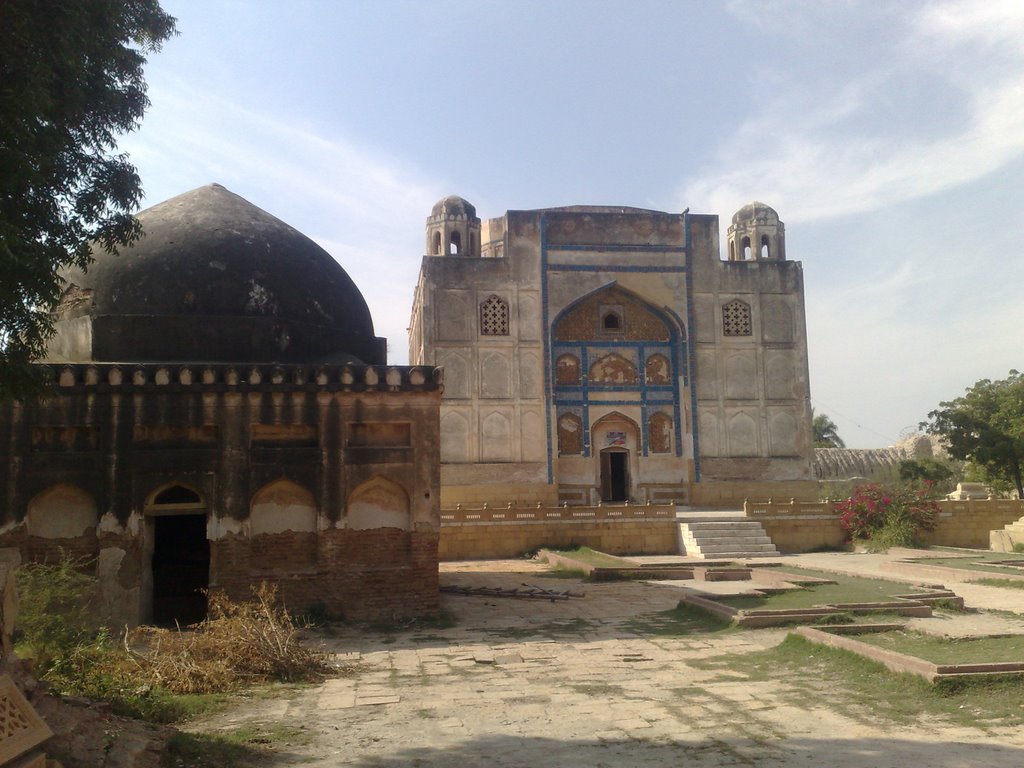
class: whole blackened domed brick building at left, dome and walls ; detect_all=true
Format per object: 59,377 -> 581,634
0,184 -> 441,624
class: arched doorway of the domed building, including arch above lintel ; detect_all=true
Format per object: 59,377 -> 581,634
142,484 -> 210,627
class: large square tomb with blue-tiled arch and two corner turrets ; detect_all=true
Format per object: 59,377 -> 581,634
410,197 -> 816,508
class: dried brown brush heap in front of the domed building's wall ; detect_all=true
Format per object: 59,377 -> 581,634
124,584 -> 333,693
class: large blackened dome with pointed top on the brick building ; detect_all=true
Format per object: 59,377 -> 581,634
47,184 -> 386,365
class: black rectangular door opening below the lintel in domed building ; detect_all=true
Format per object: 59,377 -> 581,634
153,513 -> 210,627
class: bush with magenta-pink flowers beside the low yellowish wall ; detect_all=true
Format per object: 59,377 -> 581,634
836,484 -> 939,549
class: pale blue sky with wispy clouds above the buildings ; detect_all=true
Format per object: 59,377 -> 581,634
120,0 -> 1024,447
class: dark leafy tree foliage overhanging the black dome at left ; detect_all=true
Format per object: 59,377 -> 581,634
0,0 -> 175,400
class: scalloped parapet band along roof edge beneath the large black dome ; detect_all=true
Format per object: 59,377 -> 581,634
42,362 -> 444,392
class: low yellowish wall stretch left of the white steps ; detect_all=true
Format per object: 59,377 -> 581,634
437,504 -> 679,560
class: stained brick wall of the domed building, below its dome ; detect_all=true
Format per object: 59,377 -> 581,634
0,364 -> 441,625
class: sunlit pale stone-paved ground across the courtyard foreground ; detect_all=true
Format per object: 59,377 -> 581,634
191,560 -> 1024,768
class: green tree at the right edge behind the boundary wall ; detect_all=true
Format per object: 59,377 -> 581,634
921,371 -> 1024,498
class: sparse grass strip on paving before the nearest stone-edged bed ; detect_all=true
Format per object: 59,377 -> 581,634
689,635 -> 1024,728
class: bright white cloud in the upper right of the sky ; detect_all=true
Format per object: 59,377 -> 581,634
680,2 -> 1024,221
